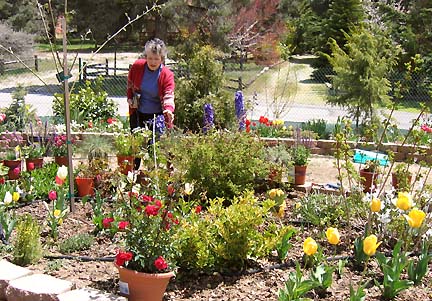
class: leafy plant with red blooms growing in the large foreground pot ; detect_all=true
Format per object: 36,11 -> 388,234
113,173 -> 179,273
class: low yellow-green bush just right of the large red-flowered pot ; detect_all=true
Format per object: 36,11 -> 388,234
176,191 -> 289,272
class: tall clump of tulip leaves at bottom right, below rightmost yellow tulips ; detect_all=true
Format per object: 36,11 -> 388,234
375,241 -> 413,300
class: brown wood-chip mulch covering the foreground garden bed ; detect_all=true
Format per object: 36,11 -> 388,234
1,192 -> 432,301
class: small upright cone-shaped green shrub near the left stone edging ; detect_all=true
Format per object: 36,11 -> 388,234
13,214 -> 42,266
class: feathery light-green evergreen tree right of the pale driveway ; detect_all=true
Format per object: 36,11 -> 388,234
327,27 -> 399,127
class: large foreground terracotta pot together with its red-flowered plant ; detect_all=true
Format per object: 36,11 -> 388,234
114,177 -> 179,301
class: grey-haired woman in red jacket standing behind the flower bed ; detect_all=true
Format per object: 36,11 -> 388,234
127,38 -> 175,169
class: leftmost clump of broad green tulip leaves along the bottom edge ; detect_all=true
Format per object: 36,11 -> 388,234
278,262 -> 314,301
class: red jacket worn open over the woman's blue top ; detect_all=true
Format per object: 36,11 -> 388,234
127,59 -> 175,115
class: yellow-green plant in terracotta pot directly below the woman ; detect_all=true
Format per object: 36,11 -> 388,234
114,129 -> 150,174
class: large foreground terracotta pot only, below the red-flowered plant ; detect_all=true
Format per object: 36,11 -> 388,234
114,264 -> 174,301
